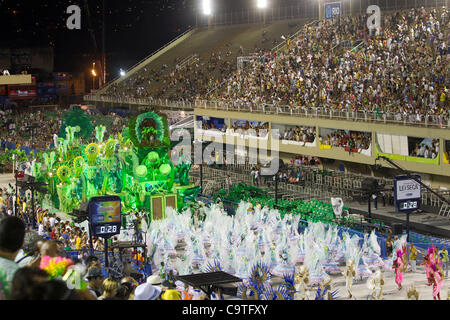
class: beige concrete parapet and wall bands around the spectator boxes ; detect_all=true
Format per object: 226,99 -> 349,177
195,109 -> 450,187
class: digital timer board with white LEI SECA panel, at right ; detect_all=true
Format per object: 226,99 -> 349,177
394,176 -> 422,212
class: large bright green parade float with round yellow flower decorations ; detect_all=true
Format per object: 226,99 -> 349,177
32,110 -> 200,226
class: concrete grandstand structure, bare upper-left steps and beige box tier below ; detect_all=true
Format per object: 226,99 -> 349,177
85,1 -> 450,188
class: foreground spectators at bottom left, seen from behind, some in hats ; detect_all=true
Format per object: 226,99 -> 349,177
0,209 -> 223,301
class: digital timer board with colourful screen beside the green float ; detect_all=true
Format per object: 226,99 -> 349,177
88,196 -> 122,239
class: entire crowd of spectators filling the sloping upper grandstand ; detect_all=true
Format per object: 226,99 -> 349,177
93,8 -> 450,125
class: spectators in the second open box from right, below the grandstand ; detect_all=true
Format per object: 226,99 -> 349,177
319,130 -> 372,150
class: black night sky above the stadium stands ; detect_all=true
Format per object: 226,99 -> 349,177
0,0 -> 299,78
